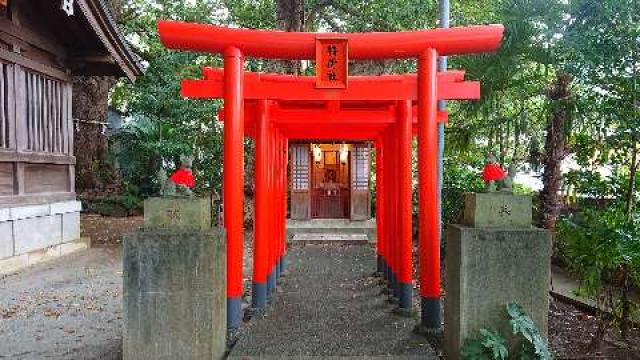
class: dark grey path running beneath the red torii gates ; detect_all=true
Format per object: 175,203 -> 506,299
230,245 -> 435,359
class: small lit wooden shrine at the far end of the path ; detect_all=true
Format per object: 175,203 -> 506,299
290,142 -> 371,220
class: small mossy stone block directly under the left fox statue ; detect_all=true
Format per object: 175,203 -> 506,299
144,197 -> 212,230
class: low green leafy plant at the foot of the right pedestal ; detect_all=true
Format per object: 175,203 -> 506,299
462,303 -> 553,360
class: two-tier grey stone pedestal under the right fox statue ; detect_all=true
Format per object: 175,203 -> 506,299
444,194 -> 551,360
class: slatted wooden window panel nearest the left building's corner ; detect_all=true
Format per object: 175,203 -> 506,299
25,72 -> 70,153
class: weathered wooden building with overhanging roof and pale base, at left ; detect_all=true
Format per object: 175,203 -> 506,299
0,0 -> 141,273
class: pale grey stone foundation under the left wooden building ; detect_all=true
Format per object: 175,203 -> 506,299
0,201 -> 82,274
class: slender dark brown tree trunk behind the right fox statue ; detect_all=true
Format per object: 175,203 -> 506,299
540,72 -> 571,230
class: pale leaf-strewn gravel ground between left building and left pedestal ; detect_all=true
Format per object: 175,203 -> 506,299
0,248 -> 122,359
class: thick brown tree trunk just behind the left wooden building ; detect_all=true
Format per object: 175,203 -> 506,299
72,76 -> 117,192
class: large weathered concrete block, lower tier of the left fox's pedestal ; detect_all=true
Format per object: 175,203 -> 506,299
123,229 -> 227,360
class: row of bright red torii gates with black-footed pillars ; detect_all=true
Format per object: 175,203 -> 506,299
158,21 -> 504,330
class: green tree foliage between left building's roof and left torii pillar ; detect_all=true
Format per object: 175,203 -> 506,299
111,0 -> 225,196
